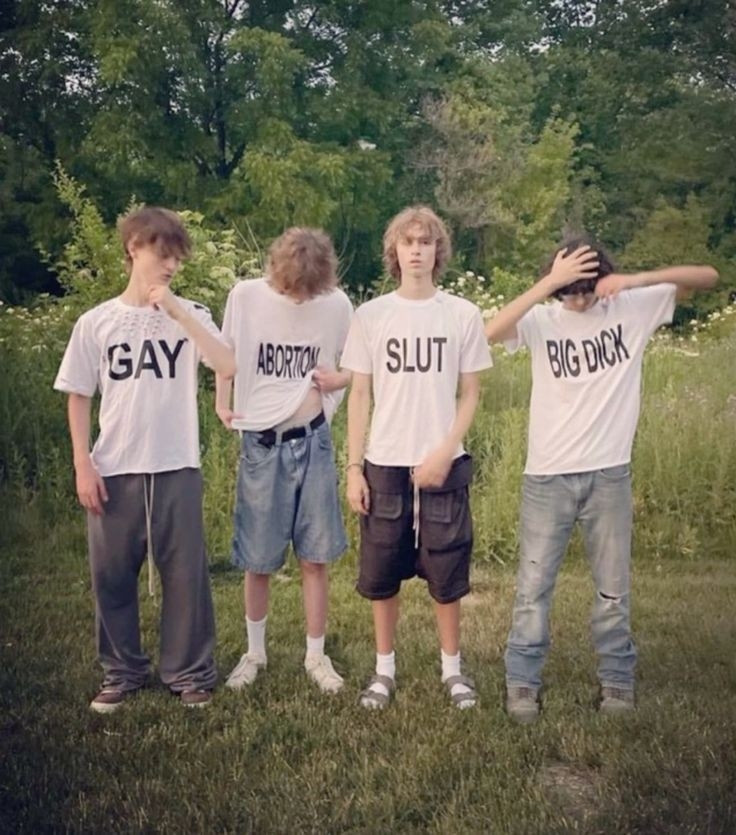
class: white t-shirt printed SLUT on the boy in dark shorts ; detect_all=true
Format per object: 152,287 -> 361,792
342,290 -> 491,467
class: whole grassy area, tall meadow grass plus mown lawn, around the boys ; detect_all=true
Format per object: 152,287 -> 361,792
0,316 -> 736,835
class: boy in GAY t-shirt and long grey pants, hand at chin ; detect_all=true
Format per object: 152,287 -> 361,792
54,207 -> 235,713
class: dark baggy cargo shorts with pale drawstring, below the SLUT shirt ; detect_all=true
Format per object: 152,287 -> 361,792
357,455 -> 473,603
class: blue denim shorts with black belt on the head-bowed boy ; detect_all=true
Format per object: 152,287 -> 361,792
232,422 -> 347,574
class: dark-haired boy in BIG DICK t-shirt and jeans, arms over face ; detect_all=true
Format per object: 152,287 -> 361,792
486,240 -> 717,722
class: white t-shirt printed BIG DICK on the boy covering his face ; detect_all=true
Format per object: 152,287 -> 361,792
505,284 -> 676,475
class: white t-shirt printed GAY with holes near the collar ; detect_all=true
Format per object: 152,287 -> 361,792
54,298 -> 220,476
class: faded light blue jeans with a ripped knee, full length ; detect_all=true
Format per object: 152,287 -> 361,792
506,464 -> 636,691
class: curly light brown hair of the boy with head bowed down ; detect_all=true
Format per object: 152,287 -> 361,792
267,226 -> 337,299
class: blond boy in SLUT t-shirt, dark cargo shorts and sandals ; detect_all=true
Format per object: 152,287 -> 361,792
342,206 -> 491,708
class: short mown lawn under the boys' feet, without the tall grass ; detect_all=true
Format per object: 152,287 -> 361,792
0,502 -> 736,833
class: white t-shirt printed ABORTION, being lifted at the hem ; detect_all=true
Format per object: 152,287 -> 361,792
222,278 -> 353,431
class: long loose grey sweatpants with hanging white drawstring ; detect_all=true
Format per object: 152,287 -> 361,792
87,468 -> 217,693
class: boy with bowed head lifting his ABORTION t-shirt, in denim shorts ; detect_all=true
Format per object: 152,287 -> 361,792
216,227 -> 352,693
